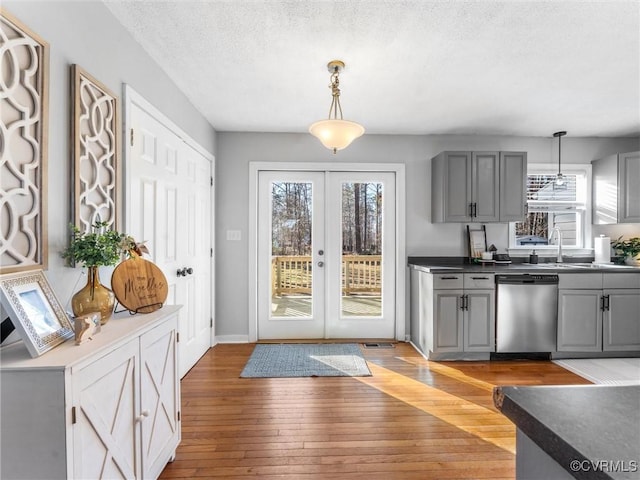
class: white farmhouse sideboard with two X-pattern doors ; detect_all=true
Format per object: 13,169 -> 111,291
0,306 -> 181,479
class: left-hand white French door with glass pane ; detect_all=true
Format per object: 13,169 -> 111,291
258,172 -> 325,339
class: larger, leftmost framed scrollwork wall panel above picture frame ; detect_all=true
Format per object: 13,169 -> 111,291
0,10 -> 49,273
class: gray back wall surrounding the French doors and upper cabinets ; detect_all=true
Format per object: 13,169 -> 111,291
216,132 -> 640,336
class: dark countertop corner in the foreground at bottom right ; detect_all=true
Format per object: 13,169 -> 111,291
493,385 -> 640,479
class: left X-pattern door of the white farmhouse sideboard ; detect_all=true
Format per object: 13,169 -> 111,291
72,338 -> 140,479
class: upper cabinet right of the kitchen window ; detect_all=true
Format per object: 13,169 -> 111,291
591,152 -> 640,225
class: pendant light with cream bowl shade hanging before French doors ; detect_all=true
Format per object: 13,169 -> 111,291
309,60 -> 364,154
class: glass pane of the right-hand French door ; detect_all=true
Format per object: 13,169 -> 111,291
340,182 -> 383,317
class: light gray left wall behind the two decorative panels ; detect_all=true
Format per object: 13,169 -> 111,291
2,0 -> 216,316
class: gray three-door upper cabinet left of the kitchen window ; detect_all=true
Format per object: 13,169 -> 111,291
431,152 -> 527,222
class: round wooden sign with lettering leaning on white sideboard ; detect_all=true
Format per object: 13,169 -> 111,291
111,257 -> 169,313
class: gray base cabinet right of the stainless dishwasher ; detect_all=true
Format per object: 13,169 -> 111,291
557,273 -> 640,352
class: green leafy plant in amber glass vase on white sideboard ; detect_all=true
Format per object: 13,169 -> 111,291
61,222 -> 132,325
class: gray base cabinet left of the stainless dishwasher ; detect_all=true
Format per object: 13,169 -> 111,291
411,270 -> 495,360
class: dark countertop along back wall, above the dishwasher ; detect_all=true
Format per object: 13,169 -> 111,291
407,257 -> 640,274
